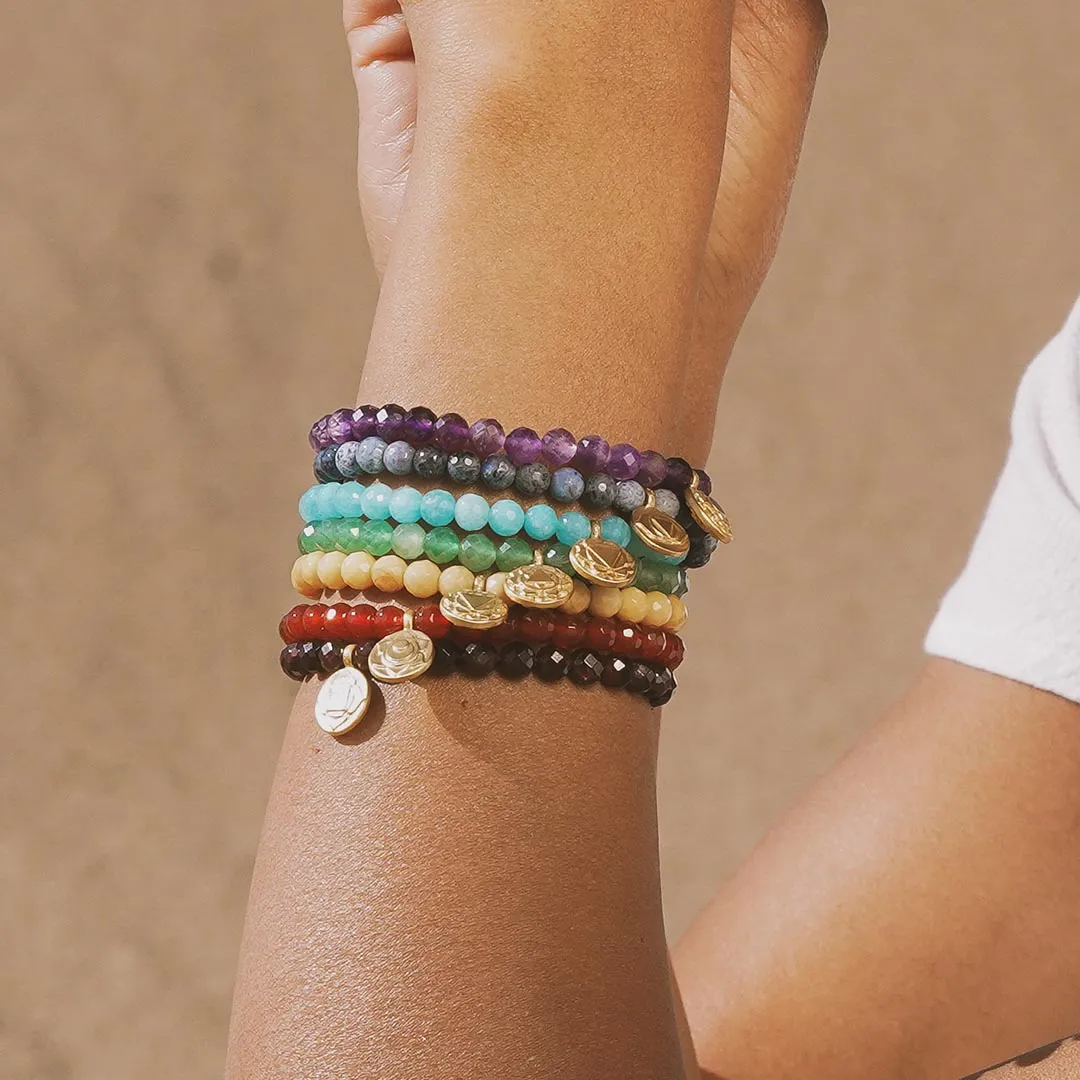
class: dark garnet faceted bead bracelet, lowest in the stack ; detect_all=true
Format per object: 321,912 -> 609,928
281,639 -> 676,708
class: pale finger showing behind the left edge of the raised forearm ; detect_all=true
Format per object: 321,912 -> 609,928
343,0 -> 416,275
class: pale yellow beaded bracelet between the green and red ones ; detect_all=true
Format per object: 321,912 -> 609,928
292,551 -> 687,633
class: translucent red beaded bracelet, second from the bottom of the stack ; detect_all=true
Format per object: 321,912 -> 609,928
278,604 -> 685,670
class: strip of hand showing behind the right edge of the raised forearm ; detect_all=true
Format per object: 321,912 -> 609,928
681,0 -> 828,459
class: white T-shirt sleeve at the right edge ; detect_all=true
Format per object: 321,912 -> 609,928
926,302 -> 1080,702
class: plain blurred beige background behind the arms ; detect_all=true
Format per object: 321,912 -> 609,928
0,0 -> 1080,1080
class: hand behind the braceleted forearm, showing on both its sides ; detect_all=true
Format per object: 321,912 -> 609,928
345,0 -> 827,451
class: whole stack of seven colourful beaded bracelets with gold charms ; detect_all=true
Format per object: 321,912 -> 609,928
280,405 -> 731,734
